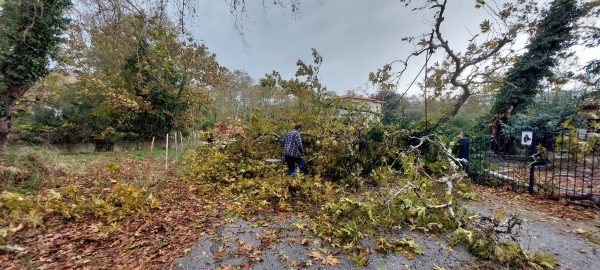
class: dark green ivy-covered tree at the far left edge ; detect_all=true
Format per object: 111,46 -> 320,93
0,0 -> 71,148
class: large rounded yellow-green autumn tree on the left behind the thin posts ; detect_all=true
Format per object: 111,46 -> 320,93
63,11 -> 225,143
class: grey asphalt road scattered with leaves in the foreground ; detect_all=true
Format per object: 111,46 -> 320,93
174,198 -> 600,269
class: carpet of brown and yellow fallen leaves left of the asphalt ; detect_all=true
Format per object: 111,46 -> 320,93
0,153 -> 222,269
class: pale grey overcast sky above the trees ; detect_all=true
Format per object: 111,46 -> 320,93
190,0 -> 598,96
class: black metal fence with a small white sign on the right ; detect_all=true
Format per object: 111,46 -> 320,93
460,130 -> 600,206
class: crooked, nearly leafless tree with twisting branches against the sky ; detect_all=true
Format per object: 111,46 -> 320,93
369,0 -> 538,133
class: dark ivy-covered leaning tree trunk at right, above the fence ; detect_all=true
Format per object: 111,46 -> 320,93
492,0 -> 580,114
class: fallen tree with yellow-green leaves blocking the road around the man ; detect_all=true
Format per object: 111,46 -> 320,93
183,93 -> 554,268
